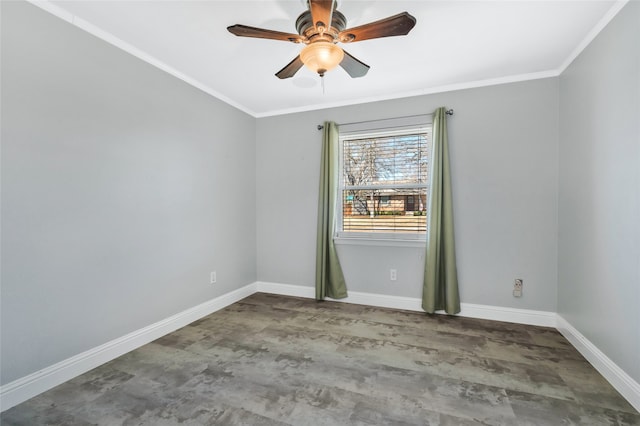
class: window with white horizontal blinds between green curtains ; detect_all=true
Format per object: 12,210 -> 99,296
337,125 -> 431,239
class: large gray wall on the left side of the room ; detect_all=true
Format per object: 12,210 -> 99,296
1,2 -> 256,384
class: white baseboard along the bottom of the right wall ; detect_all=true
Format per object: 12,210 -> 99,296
557,314 -> 640,411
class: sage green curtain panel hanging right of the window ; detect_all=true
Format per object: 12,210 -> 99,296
422,107 -> 460,314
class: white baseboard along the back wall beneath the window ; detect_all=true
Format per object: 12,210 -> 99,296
257,281 -> 556,327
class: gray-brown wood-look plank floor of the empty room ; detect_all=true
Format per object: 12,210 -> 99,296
0,293 -> 640,426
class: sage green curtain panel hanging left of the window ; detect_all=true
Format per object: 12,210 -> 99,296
316,122 -> 347,300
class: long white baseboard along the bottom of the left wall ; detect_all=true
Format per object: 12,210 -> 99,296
0,283 -> 256,411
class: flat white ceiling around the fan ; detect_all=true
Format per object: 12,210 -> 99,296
34,0 -> 625,117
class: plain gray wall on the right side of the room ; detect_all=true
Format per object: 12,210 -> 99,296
558,2 -> 640,382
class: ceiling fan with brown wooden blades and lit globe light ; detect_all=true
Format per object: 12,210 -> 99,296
227,0 -> 416,78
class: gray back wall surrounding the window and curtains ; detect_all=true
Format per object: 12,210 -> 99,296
256,78 -> 558,312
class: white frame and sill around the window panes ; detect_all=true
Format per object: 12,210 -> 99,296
333,121 -> 433,247
